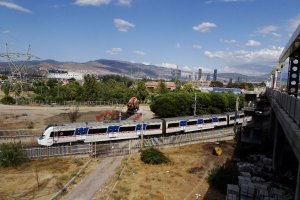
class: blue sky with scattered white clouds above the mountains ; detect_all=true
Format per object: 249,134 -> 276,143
0,0 -> 300,75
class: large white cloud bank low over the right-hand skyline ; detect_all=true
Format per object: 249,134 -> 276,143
204,46 -> 283,65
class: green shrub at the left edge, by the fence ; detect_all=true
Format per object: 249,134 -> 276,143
0,142 -> 27,167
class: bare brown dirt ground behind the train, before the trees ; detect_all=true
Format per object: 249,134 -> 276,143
0,104 -> 154,130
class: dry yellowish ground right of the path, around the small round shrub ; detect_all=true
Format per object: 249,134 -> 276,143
94,141 -> 234,200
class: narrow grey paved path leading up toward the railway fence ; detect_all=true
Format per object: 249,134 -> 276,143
64,156 -> 123,200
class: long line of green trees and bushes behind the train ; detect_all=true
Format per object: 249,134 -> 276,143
1,75 -> 244,117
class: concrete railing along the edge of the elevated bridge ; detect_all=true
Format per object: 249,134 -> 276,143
266,89 -> 300,126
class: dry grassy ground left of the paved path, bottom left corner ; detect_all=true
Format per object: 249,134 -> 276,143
0,157 -> 99,200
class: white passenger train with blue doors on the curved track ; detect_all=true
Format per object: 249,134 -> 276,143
38,113 -> 252,146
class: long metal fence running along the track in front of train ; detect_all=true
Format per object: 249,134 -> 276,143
24,128 -> 234,159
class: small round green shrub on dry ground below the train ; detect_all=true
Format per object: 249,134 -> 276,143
141,147 -> 170,165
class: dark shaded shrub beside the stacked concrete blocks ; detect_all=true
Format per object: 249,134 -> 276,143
208,160 -> 239,194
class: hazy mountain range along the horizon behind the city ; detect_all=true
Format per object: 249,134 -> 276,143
0,59 -> 267,82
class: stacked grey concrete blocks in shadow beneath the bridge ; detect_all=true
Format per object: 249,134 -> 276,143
226,155 -> 294,200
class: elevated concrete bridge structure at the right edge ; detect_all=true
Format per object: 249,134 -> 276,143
266,25 -> 300,200
